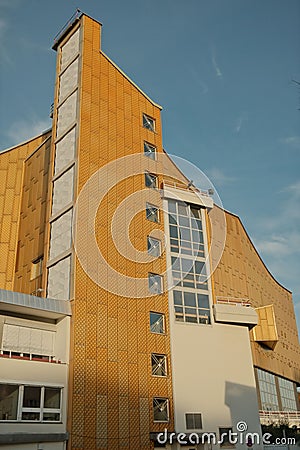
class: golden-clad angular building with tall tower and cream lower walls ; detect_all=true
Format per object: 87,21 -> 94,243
0,11 -> 300,450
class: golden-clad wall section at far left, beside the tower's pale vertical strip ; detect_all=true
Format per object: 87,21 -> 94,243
0,133 -> 49,292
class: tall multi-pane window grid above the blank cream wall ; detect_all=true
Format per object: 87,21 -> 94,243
168,200 -> 211,325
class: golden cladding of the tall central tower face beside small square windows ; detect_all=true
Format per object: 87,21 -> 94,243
69,12 -> 174,450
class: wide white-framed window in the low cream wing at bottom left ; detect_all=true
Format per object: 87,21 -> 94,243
0,384 -> 62,422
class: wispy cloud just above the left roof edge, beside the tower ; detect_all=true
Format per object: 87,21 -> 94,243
2,118 -> 51,149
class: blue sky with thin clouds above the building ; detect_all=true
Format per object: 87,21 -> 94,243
0,0 -> 300,328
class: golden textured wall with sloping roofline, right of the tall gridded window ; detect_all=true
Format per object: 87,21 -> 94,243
213,213 -> 300,382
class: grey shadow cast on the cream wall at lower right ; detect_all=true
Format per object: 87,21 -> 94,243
225,381 -> 263,450
